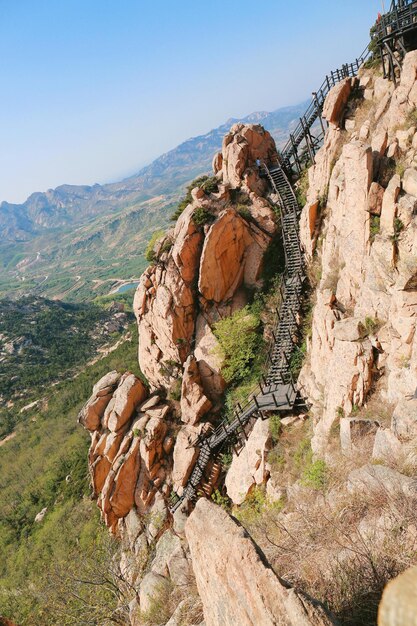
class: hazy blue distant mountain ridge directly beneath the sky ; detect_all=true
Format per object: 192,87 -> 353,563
0,103 -> 305,243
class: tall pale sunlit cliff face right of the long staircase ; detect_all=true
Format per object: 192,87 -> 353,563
300,52 -> 417,454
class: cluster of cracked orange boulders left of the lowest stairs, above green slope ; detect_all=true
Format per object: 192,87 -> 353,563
79,372 -> 171,534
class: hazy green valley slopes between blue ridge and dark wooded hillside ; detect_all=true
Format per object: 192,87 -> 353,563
0,196 -> 176,302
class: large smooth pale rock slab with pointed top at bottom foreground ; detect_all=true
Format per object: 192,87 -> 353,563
185,499 -> 336,626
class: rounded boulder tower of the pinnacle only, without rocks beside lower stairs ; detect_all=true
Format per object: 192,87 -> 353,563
134,124 -> 276,402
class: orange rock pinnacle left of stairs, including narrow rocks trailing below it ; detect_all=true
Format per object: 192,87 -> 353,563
134,124 -> 276,495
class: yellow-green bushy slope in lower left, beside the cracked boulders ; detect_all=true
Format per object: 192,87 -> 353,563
0,328 -> 140,626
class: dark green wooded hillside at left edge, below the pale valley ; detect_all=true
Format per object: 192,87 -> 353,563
0,296 -> 132,438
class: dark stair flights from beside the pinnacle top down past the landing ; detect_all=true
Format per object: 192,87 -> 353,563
171,164 -> 305,512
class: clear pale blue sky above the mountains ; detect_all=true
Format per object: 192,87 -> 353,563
0,0 -> 380,202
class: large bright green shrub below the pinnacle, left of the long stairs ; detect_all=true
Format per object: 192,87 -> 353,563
214,306 -> 263,384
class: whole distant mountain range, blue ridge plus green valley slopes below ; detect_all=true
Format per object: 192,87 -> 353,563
0,102 -> 306,300
